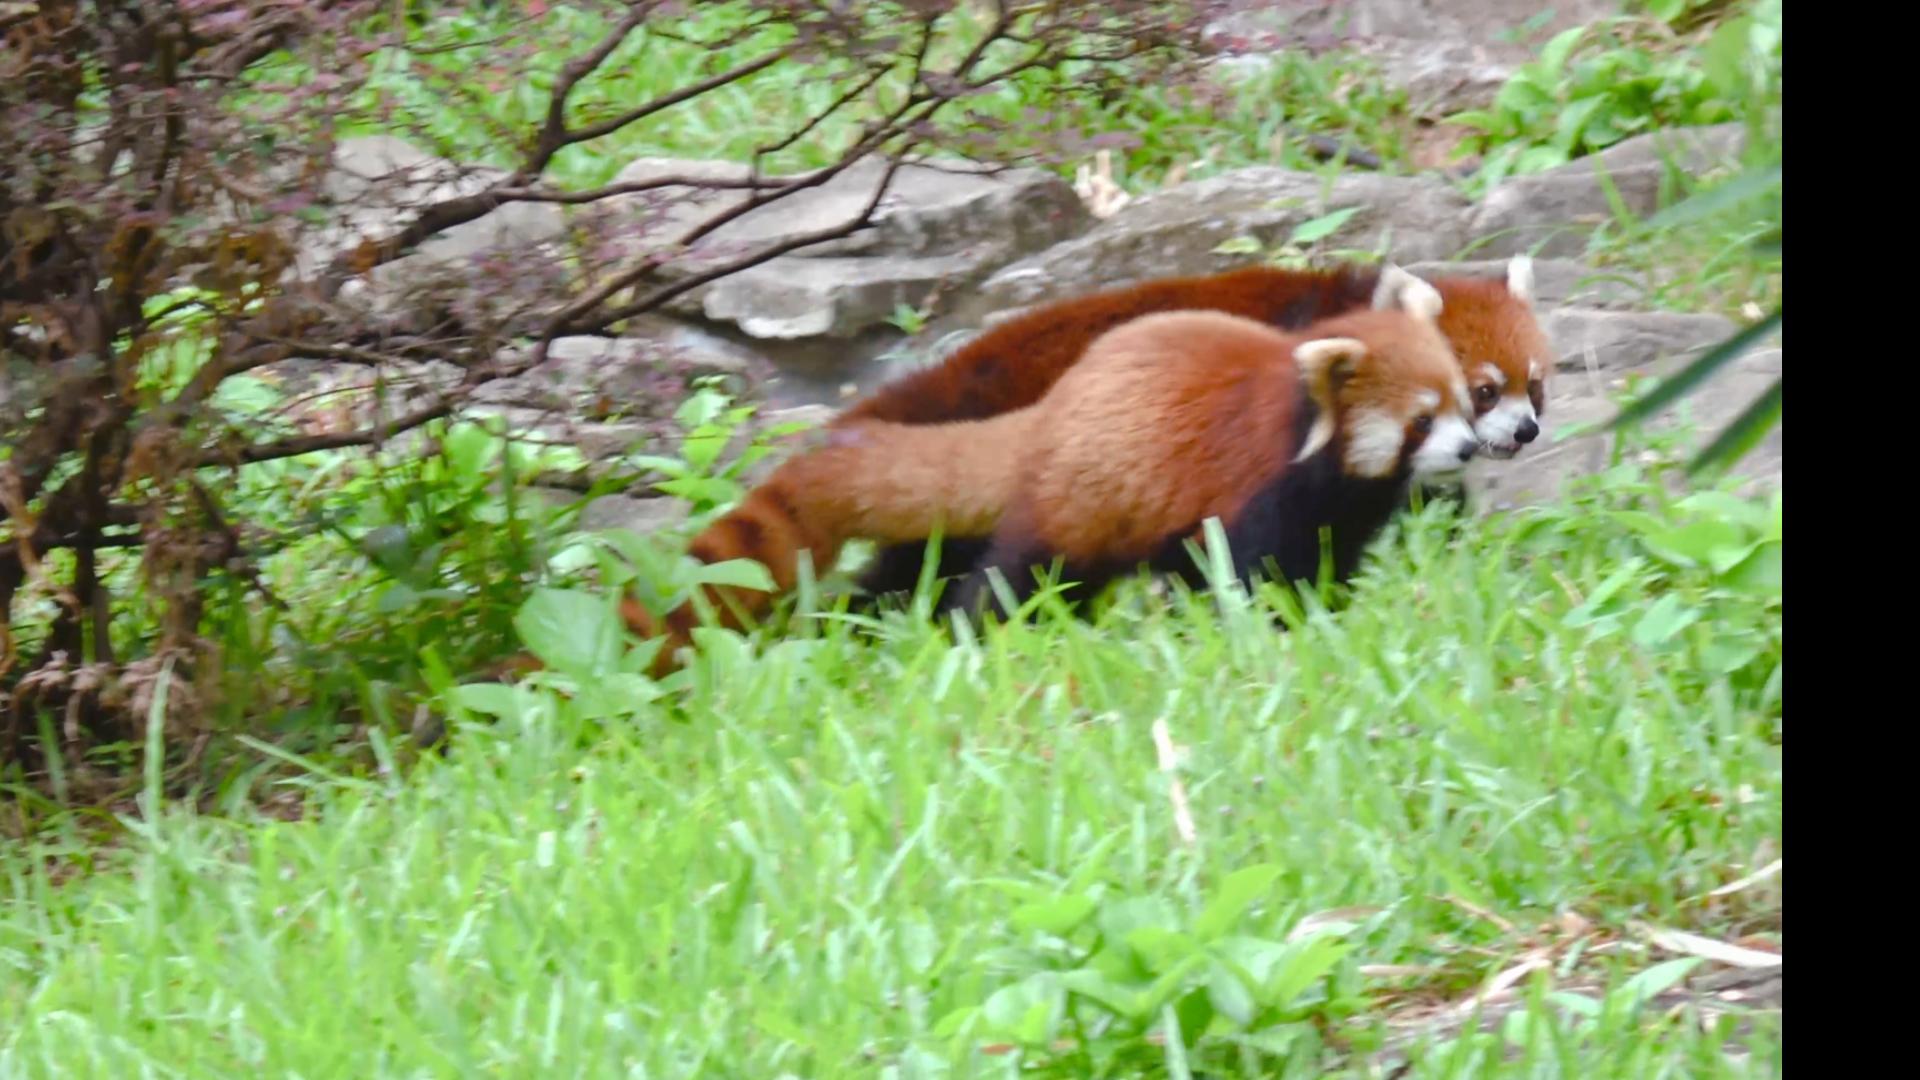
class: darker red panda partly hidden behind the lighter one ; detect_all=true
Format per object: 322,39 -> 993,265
848,256 -> 1553,594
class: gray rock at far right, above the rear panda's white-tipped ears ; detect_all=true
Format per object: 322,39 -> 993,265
1471,125 -> 1745,256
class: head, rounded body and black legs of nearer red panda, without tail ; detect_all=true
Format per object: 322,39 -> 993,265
948,298 -> 1480,607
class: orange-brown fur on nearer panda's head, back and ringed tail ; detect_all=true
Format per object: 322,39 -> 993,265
626,299 -> 1459,673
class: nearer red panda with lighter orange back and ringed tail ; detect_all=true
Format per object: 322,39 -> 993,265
628,269 -> 1478,671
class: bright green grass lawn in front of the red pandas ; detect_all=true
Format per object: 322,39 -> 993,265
0,443 -> 1782,1076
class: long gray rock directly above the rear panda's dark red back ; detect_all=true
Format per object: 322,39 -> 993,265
975,165 -> 1469,317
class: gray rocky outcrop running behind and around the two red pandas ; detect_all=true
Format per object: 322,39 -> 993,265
303,127 -> 1780,513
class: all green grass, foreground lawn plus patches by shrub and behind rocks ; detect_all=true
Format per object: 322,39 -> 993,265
0,6 -> 1784,1078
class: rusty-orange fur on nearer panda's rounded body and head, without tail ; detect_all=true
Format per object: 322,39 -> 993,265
1008,311 -> 1459,567
